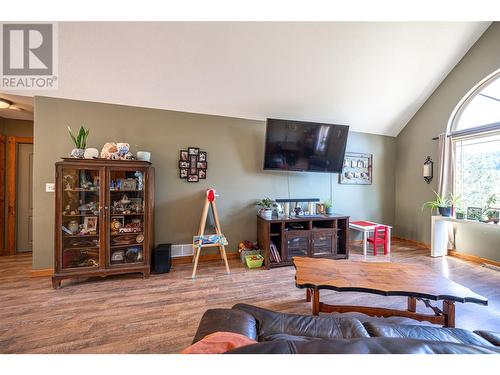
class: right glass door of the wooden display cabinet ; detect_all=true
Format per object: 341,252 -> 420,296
107,169 -> 147,266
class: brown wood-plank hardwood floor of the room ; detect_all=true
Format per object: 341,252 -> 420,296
0,241 -> 500,353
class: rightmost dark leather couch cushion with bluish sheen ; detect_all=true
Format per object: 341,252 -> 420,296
364,322 -> 493,346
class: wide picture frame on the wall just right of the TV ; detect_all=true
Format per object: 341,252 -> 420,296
339,152 -> 373,185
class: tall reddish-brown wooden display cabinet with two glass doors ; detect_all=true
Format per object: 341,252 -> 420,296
52,158 -> 154,288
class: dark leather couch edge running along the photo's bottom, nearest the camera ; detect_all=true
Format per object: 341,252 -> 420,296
228,337 -> 500,354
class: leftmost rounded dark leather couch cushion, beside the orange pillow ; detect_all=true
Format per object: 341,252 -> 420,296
193,309 -> 257,344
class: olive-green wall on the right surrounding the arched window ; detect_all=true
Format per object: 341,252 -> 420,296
395,22 -> 500,261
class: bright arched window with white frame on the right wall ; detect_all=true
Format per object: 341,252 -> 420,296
450,70 -> 500,210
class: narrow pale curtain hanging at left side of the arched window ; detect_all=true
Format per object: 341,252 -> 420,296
437,133 -> 455,249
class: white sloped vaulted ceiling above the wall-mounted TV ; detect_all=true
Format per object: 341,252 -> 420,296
0,22 -> 490,136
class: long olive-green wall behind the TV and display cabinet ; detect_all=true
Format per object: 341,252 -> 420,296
33,97 -> 396,269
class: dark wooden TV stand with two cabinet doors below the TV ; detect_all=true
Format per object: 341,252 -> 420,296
257,214 -> 349,269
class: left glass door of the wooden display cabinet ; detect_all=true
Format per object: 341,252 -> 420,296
60,166 -> 102,269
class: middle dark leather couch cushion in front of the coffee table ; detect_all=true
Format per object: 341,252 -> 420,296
233,303 -> 369,341
